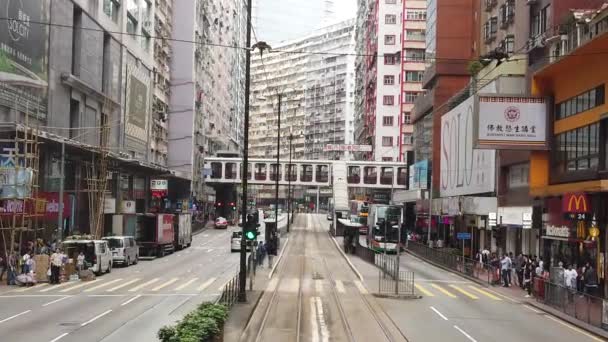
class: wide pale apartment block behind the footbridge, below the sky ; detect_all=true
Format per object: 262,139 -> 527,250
249,20 -> 354,159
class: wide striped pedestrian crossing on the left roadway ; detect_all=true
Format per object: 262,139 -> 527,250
3,277 -> 219,296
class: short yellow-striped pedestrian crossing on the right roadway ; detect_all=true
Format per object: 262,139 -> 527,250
414,282 -> 502,301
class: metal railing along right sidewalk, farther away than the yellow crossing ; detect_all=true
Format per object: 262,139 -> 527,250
407,241 -> 500,285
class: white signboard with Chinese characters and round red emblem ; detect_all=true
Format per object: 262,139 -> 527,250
475,96 -> 548,150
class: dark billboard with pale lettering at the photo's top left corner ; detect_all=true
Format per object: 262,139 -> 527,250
0,0 -> 49,119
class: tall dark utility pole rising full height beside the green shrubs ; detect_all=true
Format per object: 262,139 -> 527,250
238,0 -> 253,303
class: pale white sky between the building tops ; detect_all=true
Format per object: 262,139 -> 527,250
253,0 -> 356,43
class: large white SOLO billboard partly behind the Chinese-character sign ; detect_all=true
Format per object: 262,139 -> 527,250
439,96 -> 496,197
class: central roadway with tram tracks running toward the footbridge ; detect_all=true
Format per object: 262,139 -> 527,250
241,214 -> 405,342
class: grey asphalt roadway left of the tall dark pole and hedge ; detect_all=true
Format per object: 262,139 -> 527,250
0,224 -> 238,342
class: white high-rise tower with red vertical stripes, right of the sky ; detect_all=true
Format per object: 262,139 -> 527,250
355,0 -> 426,161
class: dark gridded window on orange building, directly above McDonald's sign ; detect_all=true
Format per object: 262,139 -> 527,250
553,123 -> 599,172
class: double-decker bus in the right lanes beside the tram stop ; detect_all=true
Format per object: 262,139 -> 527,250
367,204 -> 403,253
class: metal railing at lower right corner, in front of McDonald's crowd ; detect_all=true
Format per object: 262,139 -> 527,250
533,278 -> 608,330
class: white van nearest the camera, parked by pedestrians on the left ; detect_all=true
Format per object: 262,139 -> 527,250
62,240 -> 112,275
